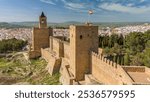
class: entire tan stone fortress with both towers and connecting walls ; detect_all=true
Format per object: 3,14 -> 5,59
29,12 -> 150,85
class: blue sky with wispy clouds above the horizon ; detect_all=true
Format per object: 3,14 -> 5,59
0,0 -> 150,22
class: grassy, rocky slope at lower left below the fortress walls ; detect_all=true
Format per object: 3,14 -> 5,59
0,53 -> 60,85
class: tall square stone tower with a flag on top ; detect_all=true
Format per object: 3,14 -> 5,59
70,25 -> 98,81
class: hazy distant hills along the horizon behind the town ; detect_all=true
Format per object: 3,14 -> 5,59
0,21 -> 147,28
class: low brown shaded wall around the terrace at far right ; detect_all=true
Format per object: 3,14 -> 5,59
123,66 -> 145,73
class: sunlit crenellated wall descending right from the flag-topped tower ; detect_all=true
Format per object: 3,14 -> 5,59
91,52 -> 132,85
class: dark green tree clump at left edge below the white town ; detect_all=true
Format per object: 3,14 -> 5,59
0,38 -> 27,53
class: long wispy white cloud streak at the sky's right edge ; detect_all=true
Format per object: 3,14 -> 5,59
99,3 -> 150,14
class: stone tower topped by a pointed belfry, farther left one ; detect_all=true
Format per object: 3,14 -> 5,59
29,12 -> 53,58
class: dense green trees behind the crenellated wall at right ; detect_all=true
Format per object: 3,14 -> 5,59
99,31 -> 150,67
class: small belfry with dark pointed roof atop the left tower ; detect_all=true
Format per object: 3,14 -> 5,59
39,12 -> 47,28
